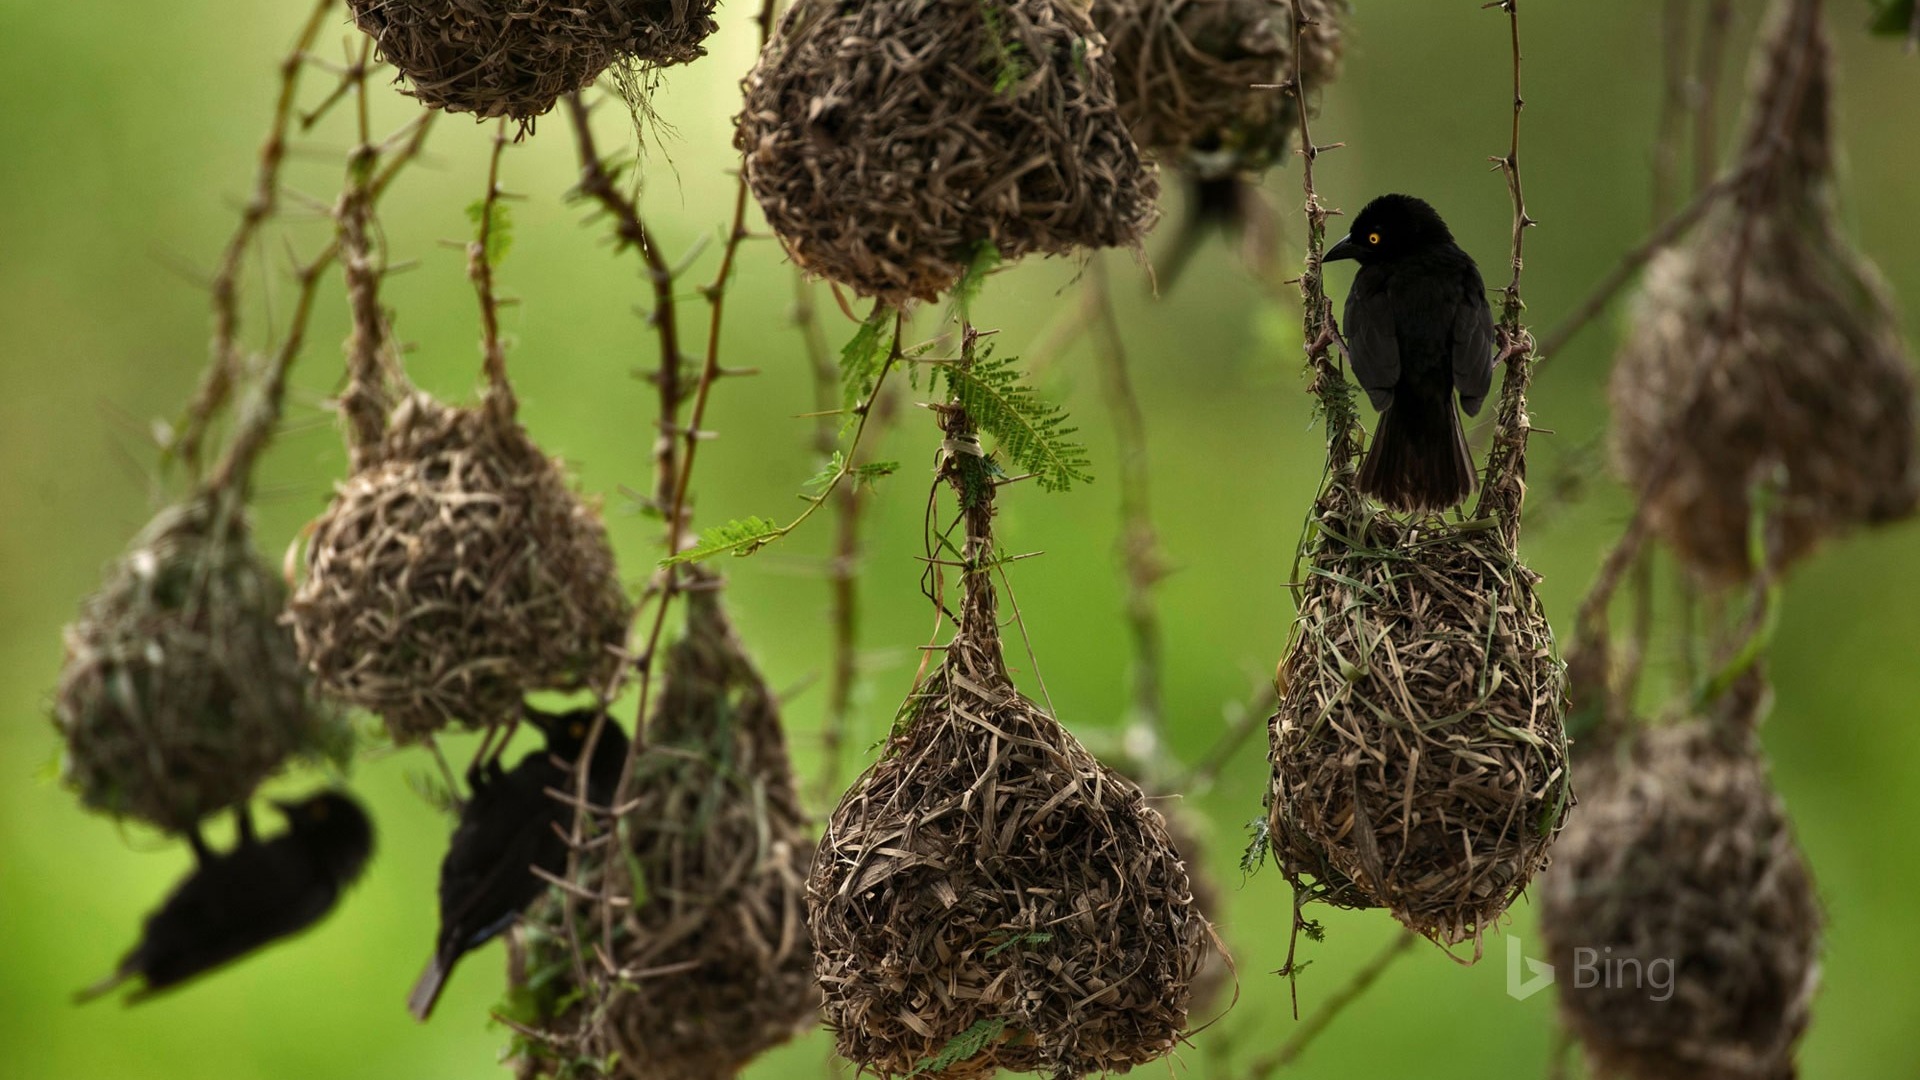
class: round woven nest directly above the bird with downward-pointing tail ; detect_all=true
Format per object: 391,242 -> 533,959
290,394 -> 630,742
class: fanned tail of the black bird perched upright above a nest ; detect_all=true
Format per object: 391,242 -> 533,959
1359,394 -> 1473,511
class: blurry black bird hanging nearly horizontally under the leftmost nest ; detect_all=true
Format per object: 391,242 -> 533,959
79,780 -> 372,1005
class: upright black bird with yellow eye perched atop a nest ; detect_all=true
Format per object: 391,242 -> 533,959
1323,194 -> 1494,511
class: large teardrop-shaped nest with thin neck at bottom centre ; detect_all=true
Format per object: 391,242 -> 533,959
806,409 -> 1212,1078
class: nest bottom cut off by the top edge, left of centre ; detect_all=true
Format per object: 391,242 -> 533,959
348,0 -> 718,121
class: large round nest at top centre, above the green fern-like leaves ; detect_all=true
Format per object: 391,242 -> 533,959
733,0 -> 1158,306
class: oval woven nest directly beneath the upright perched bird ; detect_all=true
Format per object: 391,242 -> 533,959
1269,500 -> 1572,949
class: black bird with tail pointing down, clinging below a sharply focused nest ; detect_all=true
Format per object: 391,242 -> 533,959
407,707 -> 628,1020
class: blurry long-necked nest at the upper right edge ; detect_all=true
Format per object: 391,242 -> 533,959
1611,0 -> 1920,582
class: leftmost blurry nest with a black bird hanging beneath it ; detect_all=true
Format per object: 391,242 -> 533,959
54,496 -> 342,832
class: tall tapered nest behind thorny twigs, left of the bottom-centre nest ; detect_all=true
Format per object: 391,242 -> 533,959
520,578 -> 820,1080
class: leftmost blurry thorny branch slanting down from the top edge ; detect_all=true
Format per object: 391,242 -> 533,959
167,0 -> 334,473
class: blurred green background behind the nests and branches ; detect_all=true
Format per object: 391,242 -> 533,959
0,0 -> 1920,1080
